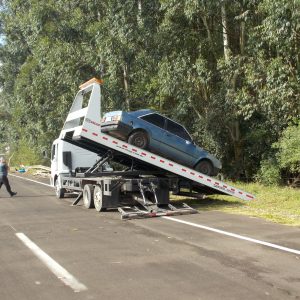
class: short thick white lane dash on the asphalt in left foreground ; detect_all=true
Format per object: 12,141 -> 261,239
16,232 -> 87,292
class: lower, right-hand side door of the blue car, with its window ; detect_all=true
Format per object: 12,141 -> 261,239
164,119 -> 196,167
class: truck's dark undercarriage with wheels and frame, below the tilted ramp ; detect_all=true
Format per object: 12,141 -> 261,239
56,152 -> 197,219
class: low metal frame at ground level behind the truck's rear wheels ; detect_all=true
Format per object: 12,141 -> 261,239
118,203 -> 198,220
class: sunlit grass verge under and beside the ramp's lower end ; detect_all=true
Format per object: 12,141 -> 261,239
171,183 -> 300,226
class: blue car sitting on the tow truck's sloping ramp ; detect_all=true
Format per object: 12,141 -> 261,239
101,109 -> 222,176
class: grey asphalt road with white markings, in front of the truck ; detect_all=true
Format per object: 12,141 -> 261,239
0,176 -> 300,300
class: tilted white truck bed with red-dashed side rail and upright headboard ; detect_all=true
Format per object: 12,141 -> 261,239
60,82 -> 255,212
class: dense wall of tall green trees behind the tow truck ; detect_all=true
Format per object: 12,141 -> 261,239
0,0 -> 300,183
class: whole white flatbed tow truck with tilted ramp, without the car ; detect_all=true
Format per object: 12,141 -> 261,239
50,78 -> 255,219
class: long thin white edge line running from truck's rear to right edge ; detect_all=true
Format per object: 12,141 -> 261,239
162,217 -> 300,255
